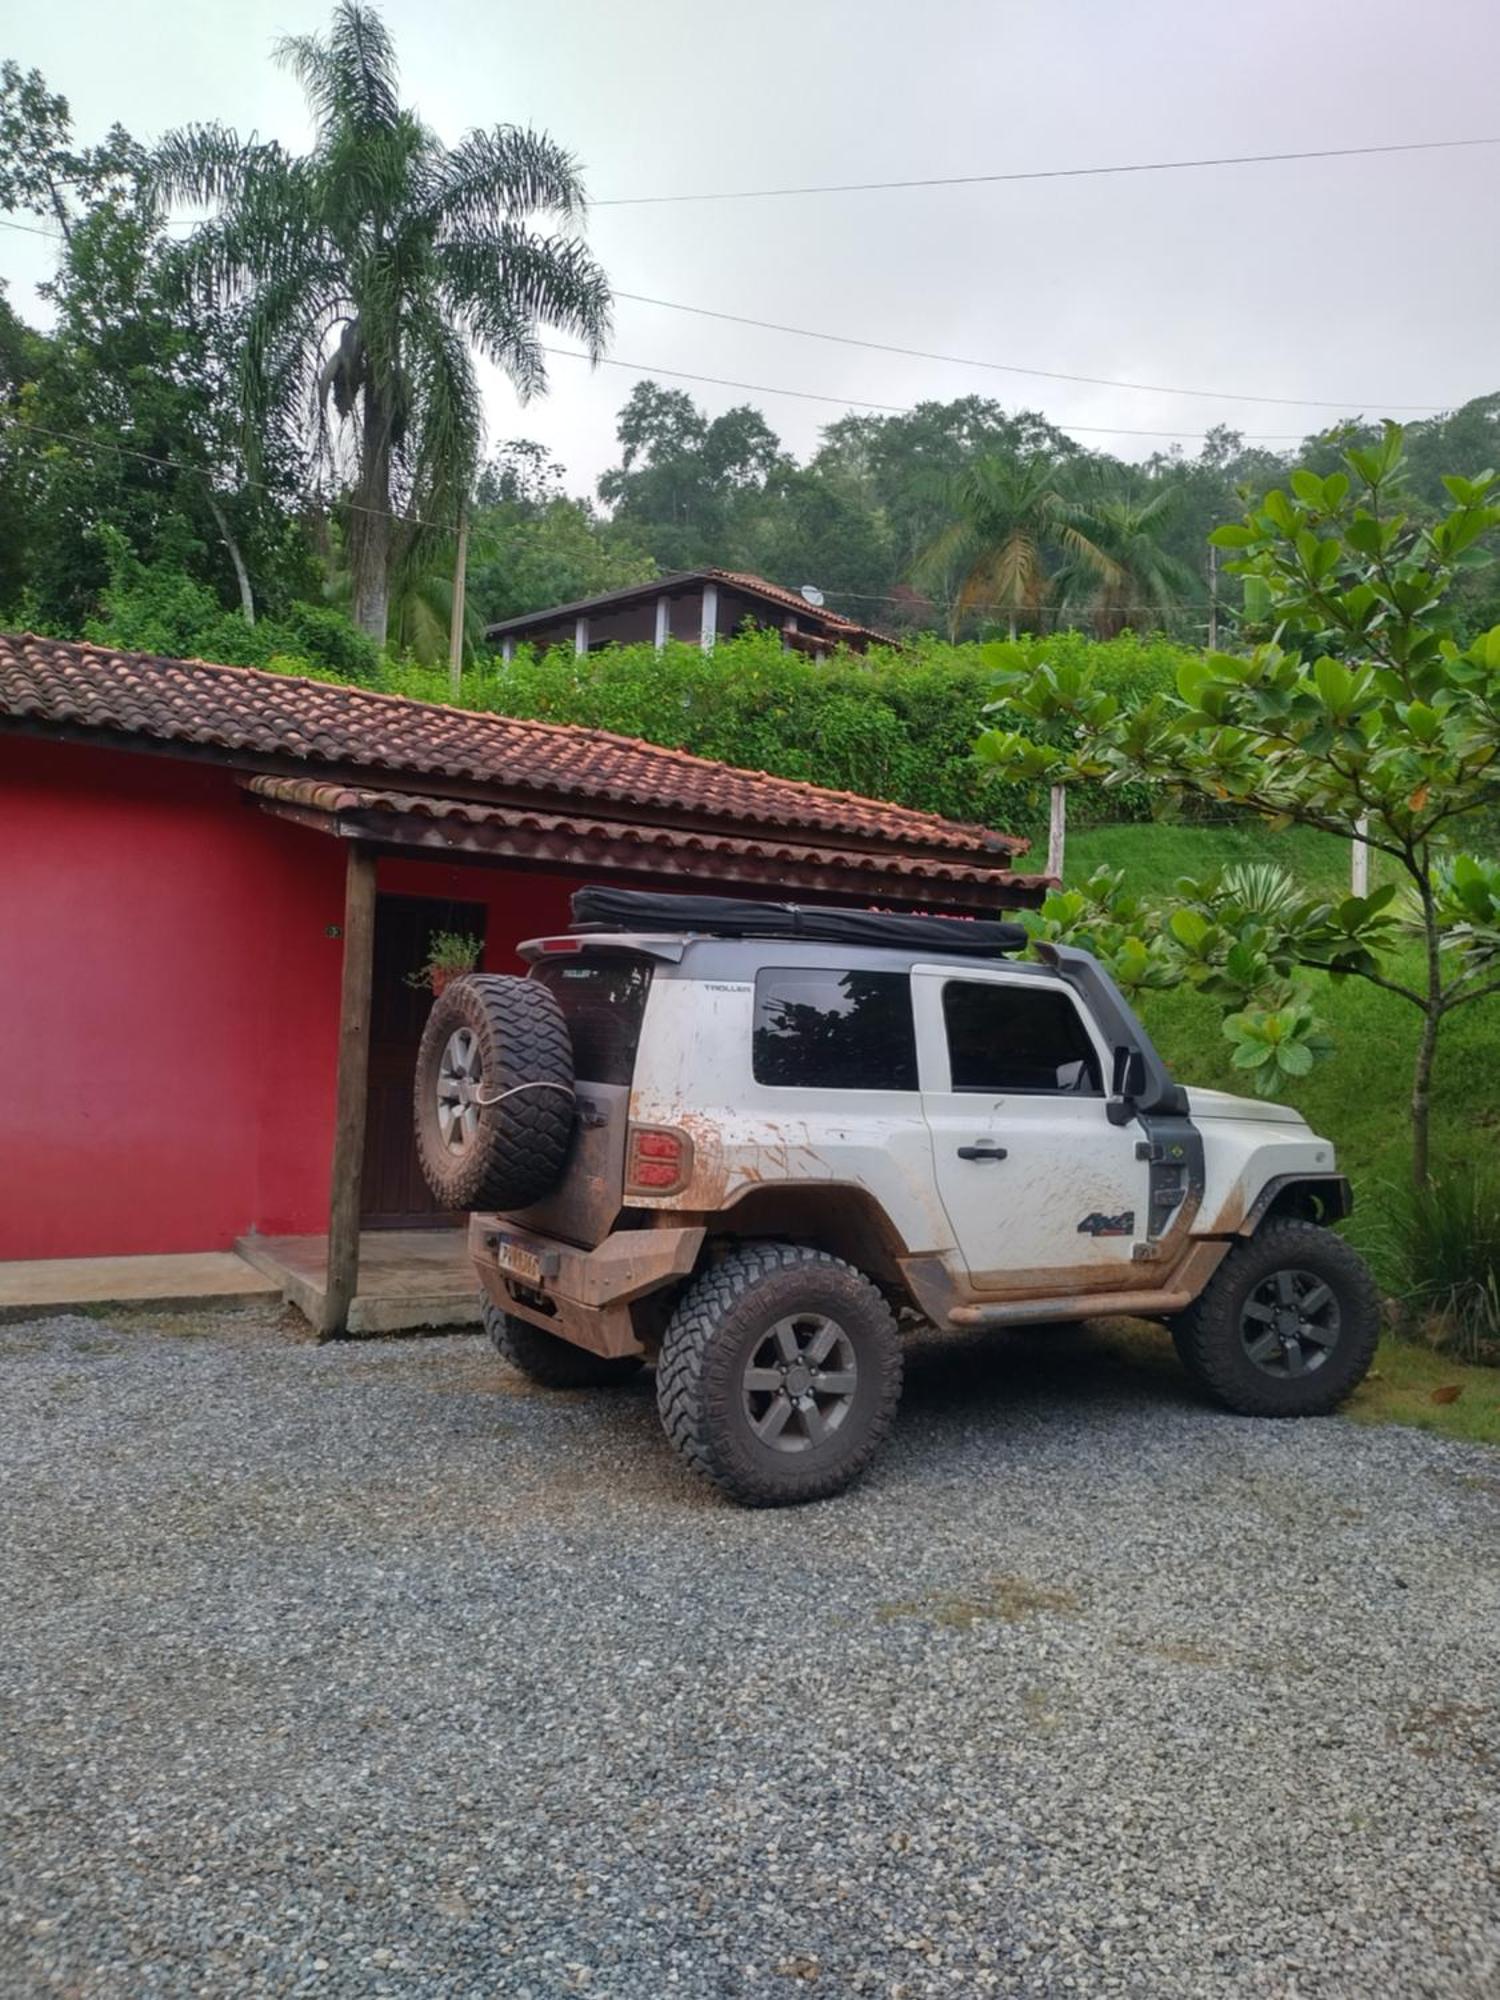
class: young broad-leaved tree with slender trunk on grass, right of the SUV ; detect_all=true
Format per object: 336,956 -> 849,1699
980,424 -> 1500,1186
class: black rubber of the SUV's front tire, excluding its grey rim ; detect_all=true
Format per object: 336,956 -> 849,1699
1170,1218 -> 1380,1416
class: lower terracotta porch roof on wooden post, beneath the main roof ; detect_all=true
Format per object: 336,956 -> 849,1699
244,776 -> 1050,908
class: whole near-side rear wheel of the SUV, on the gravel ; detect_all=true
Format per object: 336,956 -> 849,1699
656,1244 -> 902,1506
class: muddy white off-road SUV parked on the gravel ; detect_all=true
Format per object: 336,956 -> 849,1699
416,890 -> 1378,1506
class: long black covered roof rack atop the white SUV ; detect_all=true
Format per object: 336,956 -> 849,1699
572,888 -> 1030,958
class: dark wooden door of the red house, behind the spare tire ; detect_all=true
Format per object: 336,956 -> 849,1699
360,896 -> 486,1230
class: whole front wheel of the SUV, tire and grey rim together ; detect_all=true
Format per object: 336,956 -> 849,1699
1170,1218 -> 1380,1416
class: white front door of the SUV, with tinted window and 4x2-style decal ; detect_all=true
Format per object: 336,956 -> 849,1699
912,968 -> 1148,1296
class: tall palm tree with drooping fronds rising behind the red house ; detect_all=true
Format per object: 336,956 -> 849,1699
152,0 -> 610,642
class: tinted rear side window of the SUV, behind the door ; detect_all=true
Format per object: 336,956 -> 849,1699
752,966 -> 916,1090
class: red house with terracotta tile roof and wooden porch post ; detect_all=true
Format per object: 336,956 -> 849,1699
0,636 -> 1040,1330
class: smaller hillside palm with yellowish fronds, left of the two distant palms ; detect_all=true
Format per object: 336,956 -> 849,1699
916,452 -> 1108,638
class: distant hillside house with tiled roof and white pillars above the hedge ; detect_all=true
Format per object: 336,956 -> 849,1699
484,570 -> 896,660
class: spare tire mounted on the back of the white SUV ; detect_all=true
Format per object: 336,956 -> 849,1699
416,974 -> 574,1208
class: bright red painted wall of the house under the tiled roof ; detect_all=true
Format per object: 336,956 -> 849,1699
0,736 -> 574,1258
